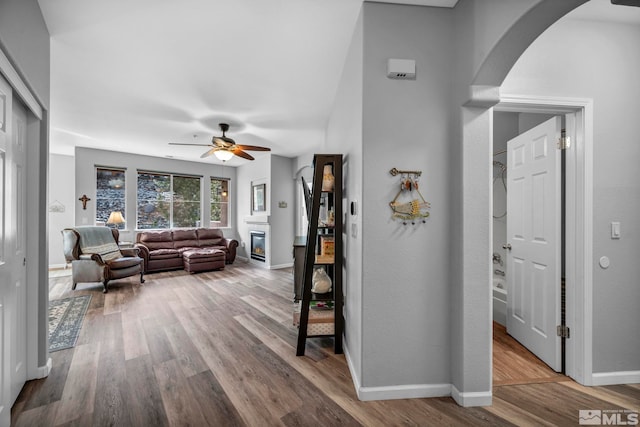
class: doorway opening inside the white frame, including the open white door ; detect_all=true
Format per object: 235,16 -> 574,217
492,111 -> 566,385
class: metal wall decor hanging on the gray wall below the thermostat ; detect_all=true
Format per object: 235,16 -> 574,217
389,168 -> 431,225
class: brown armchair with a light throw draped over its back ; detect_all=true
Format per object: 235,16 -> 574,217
62,226 -> 144,293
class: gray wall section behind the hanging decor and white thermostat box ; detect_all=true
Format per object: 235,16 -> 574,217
361,3 -> 454,388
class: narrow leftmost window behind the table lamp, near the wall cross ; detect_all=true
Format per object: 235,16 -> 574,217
96,168 -> 126,230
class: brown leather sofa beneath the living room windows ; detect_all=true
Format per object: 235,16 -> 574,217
134,228 -> 238,273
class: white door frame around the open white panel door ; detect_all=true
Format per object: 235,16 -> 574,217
490,94 -> 593,385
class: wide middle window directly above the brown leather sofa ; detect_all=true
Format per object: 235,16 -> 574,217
138,171 -> 200,229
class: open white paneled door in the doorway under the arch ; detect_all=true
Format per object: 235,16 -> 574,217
507,117 -> 562,372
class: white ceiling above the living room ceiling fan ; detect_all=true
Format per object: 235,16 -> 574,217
39,0 -> 640,166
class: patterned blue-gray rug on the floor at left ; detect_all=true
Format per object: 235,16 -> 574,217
49,295 -> 91,352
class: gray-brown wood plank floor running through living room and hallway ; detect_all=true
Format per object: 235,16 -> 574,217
12,263 -> 640,426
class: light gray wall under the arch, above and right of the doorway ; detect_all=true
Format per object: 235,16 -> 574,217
503,16 -> 640,373
